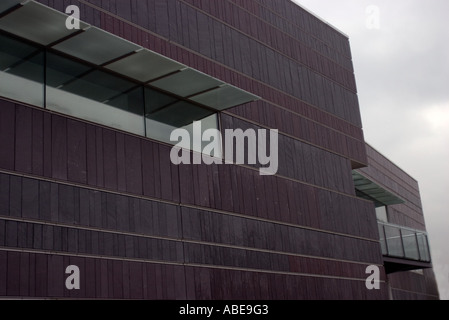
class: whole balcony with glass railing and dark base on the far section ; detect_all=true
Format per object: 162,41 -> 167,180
378,222 -> 432,273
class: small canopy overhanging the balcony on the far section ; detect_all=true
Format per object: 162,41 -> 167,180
352,170 -> 405,205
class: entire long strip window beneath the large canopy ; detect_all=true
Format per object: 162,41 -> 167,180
0,34 -> 222,157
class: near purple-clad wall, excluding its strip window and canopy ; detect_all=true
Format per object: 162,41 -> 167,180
0,0 -> 388,299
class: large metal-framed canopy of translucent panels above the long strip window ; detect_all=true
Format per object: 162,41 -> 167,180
0,0 -> 260,111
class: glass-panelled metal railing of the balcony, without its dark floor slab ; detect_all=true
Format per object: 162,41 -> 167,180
378,222 -> 431,262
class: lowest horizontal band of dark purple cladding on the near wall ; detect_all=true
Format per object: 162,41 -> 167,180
0,250 -> 387,300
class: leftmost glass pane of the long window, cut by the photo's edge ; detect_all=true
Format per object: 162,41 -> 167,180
0,34 -> 44,107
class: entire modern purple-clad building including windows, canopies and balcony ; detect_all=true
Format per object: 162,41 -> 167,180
0,0 -> 438,300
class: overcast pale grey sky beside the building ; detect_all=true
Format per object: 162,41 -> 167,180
295,0 -> 449,300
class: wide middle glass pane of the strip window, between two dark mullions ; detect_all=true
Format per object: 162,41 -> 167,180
47,53 -> 145,135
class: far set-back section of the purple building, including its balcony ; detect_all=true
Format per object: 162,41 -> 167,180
353,145 -> 438,300
